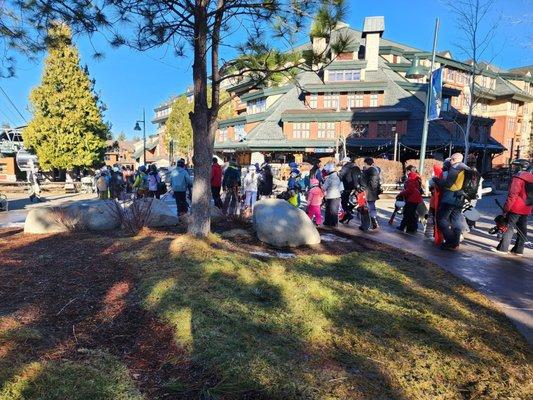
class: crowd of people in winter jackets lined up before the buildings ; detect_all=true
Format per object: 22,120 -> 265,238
96,153 -> 533,255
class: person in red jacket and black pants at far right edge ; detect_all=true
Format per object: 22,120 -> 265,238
491,160 -> 533,256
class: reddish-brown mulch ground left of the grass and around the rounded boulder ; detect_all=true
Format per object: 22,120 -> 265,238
0,220 -> 424,398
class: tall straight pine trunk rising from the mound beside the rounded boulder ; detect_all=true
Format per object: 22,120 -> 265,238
188,1 -> 213,237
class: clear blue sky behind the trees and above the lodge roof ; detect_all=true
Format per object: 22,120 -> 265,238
0,0 -> 533,137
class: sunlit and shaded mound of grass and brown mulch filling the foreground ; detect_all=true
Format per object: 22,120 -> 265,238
0,225 -> 533,400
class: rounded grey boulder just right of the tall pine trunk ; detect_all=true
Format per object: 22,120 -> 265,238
253,199 -> 320,247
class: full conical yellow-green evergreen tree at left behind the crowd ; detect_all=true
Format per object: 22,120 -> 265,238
23,23 -> 109,171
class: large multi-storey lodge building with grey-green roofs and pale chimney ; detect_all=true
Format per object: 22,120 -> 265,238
210,17 -> 533,170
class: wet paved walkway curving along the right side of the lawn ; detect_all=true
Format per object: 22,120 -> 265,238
339,196 -> 533,344
